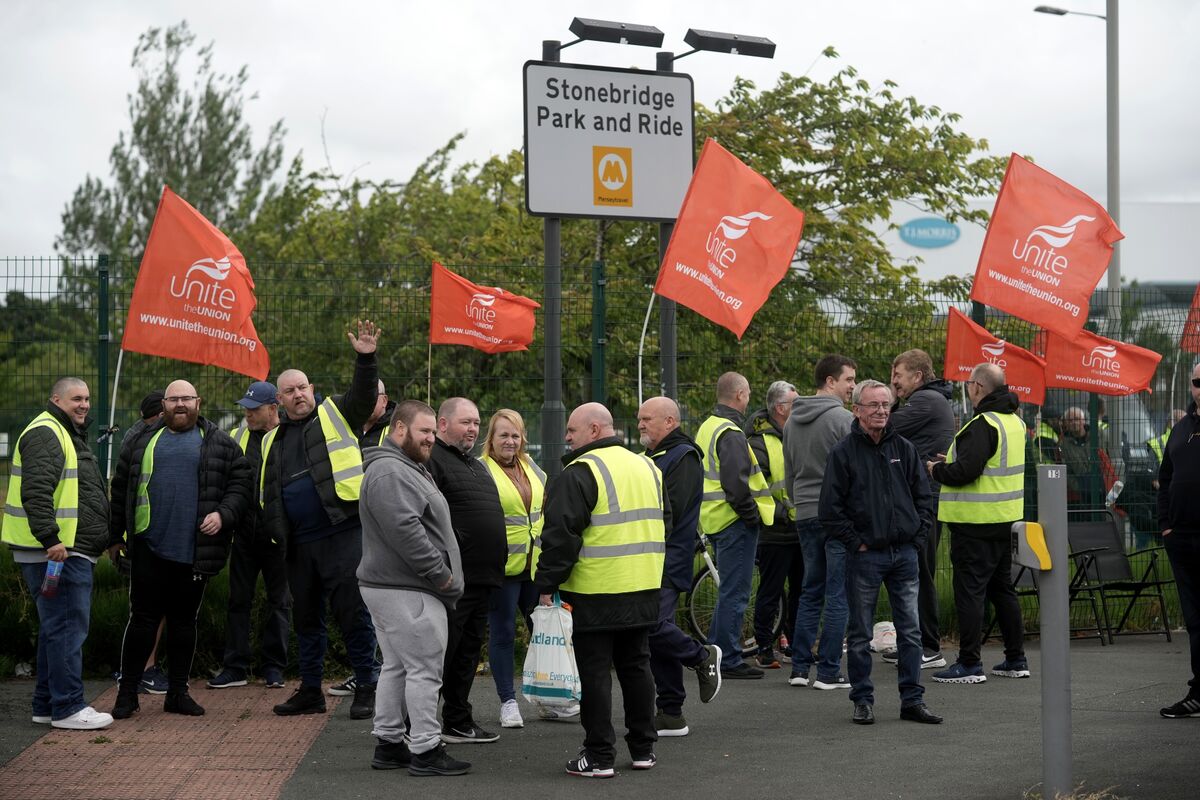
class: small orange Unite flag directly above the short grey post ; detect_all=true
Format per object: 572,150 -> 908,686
1046,331 -> 1163,395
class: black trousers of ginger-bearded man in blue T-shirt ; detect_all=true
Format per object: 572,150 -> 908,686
120,536 -> 208,694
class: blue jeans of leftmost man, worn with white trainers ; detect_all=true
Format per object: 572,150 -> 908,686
20,557 -> 94,720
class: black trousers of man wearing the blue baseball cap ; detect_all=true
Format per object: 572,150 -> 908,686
224,533 -> 292,675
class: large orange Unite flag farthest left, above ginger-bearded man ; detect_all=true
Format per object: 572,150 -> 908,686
121,186 -> 271,380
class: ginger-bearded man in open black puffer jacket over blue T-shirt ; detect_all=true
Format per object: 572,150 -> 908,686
109,380 -> 253,720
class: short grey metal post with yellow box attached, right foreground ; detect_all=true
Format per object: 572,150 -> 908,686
1038,464 -> 1075,798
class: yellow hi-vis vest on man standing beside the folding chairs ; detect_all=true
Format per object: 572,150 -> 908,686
937,411 -> 1026,525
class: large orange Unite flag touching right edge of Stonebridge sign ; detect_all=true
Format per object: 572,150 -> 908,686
654,139 -> 804,338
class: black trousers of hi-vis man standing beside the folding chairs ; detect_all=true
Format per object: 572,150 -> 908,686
949,523 -> 1025,667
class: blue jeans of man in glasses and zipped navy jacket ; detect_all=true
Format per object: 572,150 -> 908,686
846,545 -> 925,708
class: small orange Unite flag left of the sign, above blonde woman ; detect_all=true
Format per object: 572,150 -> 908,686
430,261 -> 541,353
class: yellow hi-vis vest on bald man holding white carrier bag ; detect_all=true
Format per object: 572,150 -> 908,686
560,445 -> 667,595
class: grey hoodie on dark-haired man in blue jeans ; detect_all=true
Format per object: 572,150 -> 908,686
784,395 -> 854,521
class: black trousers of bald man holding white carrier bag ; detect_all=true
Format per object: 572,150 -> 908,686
574,627 -> 659,766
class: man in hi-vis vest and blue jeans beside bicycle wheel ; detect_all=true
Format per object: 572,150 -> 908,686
696,372 -> 775,678
